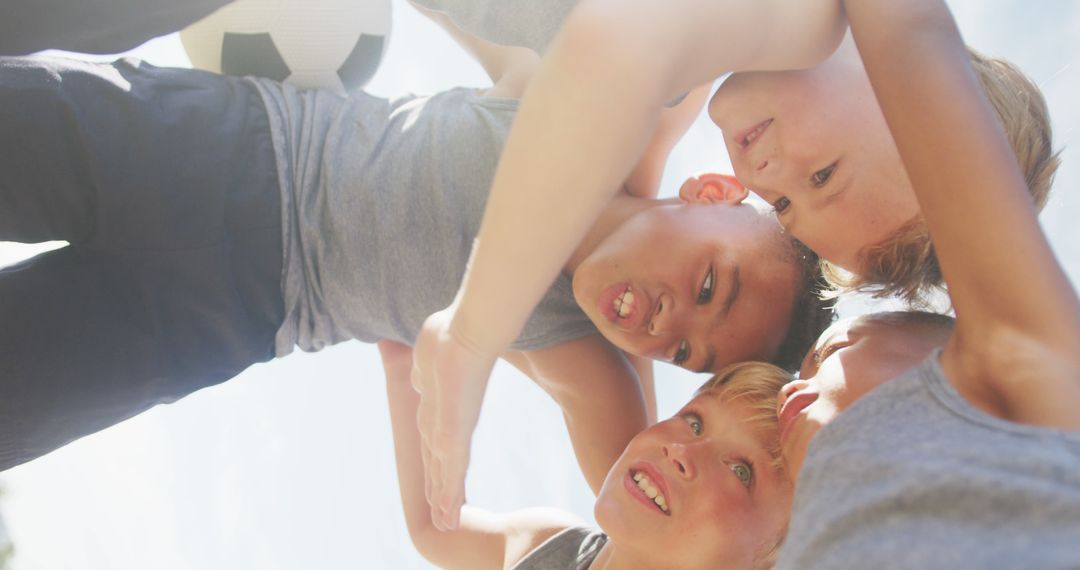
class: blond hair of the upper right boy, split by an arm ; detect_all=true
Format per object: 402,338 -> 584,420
822,48 -> 1061,306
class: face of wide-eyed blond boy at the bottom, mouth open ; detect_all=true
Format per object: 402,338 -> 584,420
595,393 -> 792,569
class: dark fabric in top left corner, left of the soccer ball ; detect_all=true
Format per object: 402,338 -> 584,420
0,0 -> 232,55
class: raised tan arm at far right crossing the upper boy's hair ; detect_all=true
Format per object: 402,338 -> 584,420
847,0 -> 1080,429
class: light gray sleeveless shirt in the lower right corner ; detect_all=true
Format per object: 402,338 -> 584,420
777,351 -> 1080,570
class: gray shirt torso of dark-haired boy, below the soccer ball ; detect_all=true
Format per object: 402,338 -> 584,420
252,79 -> 596,356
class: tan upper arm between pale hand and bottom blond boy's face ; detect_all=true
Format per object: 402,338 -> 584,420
507,335 -> 648,493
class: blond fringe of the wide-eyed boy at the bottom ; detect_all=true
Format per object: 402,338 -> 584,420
694,362 -> 794,568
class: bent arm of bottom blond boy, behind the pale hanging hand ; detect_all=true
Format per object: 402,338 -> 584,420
379,340 -> 580,570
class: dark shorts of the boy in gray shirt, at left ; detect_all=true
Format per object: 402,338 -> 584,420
0,54 -> 283,470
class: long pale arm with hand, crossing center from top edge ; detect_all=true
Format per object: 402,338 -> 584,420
414,0 -> 845,527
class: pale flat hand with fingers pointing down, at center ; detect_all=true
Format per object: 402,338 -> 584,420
411,306 -> 496,530
